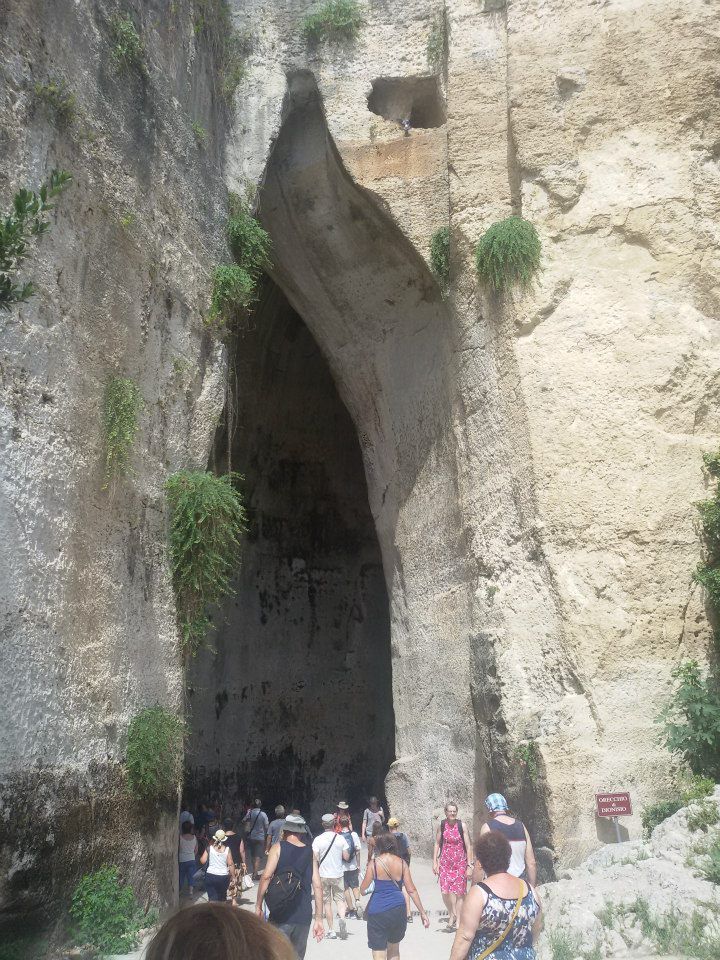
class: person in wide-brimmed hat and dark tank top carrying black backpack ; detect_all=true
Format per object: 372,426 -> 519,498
255,813 -> 325,960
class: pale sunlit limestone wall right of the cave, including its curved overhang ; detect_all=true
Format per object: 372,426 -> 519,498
228,0 -> 718,860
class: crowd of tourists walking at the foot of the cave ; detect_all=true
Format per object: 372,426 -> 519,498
158,793 -> 540,960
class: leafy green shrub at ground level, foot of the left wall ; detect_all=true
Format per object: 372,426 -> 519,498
70,867 -> 152,956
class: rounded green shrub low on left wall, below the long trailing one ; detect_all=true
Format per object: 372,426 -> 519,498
125,707 -> 184,801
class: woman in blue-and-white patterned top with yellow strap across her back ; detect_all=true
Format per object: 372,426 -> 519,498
450,833 -> 540,960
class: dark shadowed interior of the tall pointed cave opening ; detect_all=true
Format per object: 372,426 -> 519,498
187,280 -> 394,820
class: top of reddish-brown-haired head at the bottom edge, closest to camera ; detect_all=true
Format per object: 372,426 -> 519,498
146,903 -> 295,960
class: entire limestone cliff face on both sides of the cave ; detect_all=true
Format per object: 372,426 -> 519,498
0,0 -> 720,928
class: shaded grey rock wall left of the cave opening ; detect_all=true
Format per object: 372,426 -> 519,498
0,0 -> 225,919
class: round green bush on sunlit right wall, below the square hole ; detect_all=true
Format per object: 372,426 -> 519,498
475,217 -> 541,292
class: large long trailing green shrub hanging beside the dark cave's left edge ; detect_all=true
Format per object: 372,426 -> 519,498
165,470 -> 247,655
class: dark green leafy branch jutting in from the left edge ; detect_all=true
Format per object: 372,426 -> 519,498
0,170 -> 72,310
